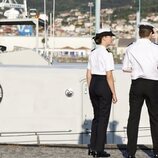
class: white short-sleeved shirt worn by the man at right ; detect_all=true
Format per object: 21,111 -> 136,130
122,38 -> 158,80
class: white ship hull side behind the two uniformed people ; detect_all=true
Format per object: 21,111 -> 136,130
0,65 -> 151,144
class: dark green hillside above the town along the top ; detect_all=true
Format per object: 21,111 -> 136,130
27,0 -> 158,19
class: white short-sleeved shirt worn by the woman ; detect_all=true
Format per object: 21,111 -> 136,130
87,45 -> 114,75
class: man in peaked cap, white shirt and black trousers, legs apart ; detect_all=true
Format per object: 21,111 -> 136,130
122,23 -> 158,158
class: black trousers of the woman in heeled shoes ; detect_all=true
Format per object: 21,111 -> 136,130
89,75 -> 112,151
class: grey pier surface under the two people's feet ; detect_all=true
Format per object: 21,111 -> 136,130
0,144 -> 153,158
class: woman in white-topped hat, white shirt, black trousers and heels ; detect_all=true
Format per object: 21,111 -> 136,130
86,28 -> 117,157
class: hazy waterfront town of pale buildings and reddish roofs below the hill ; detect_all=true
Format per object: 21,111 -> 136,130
0,2 -> 158,64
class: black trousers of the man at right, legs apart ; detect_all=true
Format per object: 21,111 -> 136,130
127,78 -> 158,155
